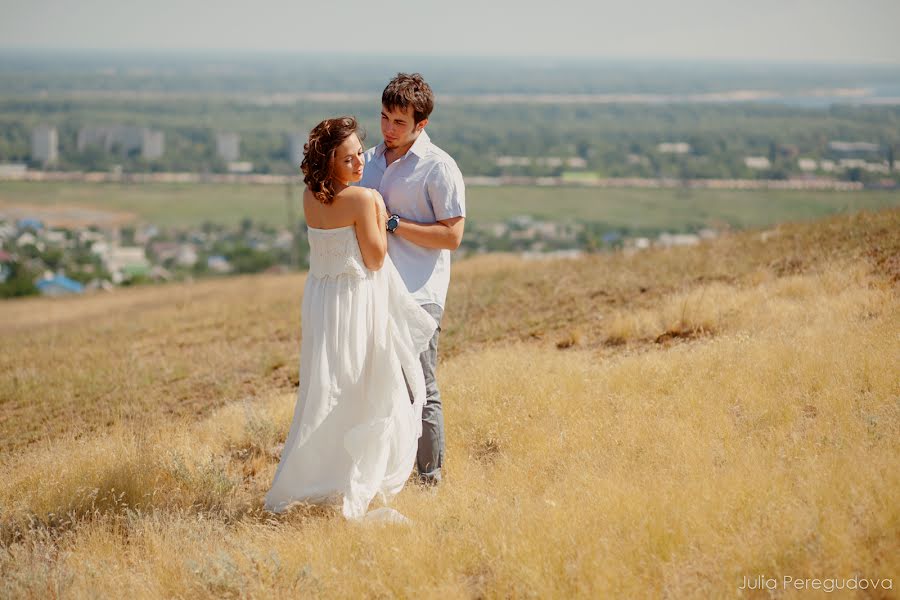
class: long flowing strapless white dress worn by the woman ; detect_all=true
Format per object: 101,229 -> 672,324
265,225 -> 436,520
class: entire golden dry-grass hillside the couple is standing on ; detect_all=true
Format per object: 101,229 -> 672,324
0,209 -> 900,599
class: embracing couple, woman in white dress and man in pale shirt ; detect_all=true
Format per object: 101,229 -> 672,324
265,73 -> 465,519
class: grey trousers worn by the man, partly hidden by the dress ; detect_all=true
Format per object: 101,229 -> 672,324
406,304 -> 444,483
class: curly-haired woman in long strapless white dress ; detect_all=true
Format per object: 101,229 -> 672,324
265,117 -> 437,519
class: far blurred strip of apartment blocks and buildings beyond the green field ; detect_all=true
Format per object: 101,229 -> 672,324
0,125 -> 898,190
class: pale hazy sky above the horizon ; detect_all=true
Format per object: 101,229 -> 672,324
0,0 -> 900,63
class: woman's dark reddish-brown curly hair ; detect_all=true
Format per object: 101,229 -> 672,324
300,117 -> 365,204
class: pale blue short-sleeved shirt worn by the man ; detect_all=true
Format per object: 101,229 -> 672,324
359,131 -> 466,308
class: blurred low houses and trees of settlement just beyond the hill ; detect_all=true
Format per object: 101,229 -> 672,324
0,209 -> 717,297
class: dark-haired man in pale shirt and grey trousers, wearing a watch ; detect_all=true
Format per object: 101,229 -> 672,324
359,73 -> 466,484
